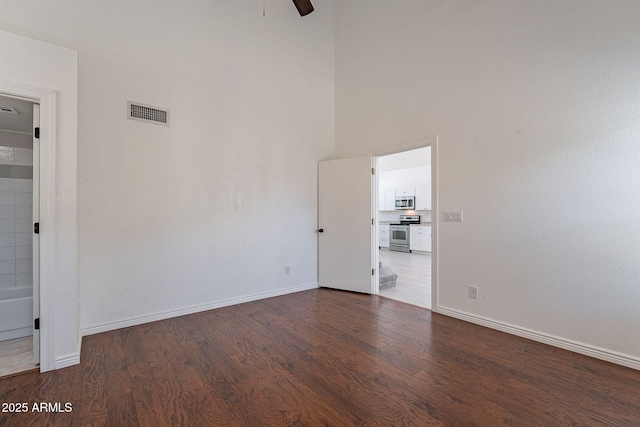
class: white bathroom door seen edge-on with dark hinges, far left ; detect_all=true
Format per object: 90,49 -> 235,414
32,104 -> 40,365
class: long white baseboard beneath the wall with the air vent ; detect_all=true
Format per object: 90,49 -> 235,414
82,282 -> 318,336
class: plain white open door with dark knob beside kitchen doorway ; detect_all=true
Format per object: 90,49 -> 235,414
318,156 -> 377,293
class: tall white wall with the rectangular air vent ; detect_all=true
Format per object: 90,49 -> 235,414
0,0 -> 334,333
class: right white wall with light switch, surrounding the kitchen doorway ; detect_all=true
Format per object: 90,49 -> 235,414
336,0 -> 640,367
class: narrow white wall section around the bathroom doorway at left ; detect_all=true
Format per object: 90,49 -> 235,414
0,29 -> 80,369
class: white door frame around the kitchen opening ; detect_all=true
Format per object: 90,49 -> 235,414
371,135 -> 440,313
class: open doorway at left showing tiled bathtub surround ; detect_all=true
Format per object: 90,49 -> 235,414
0,94 -> 40,377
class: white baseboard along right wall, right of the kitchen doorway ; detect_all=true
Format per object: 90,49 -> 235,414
434,306 -> 640,370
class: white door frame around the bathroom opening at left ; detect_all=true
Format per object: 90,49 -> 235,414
0,80 -> 57,372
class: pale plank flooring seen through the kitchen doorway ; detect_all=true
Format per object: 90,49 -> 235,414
379,249 -> 431,309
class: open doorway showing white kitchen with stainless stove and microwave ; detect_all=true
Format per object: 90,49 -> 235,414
376,146 -> 432,309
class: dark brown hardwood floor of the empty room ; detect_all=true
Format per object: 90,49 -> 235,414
0,289 -> 640,427
